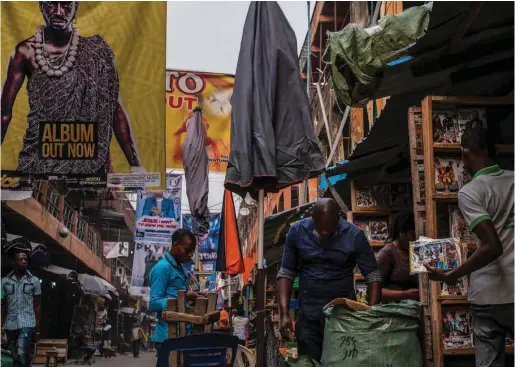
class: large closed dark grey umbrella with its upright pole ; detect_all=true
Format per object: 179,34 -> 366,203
225,2 -> 325,367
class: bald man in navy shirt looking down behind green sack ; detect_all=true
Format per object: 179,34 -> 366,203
277,199 -> 381,361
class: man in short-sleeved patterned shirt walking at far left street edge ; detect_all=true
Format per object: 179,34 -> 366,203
2,249 -> 41,367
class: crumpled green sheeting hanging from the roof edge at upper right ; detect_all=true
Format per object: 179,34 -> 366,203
327,5 -> 431,107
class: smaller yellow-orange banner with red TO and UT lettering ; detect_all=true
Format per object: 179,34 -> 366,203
166,70 -> 234,172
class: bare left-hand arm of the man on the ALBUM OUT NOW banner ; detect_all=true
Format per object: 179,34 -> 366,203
1,42 -> 31,143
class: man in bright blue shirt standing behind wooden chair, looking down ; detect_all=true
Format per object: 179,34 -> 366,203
150,229 -> 198,349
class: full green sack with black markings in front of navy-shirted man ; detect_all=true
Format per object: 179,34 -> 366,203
322,301 -> 423,367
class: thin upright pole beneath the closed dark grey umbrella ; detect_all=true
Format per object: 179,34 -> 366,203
256,190 -> 265,367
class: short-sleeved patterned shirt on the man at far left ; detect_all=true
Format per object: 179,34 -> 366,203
2,270 -> 41,330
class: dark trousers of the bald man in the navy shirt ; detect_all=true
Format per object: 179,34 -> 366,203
295,312 -> 325,362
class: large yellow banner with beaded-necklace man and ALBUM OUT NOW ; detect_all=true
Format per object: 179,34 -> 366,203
0,1 -> 166,187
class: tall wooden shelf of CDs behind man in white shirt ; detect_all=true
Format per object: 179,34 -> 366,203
408,96 -> 513,367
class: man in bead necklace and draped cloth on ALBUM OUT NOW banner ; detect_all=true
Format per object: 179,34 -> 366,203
1,1 -> 142,174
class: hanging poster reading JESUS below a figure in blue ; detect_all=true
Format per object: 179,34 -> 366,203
134,174 -> 182,244
